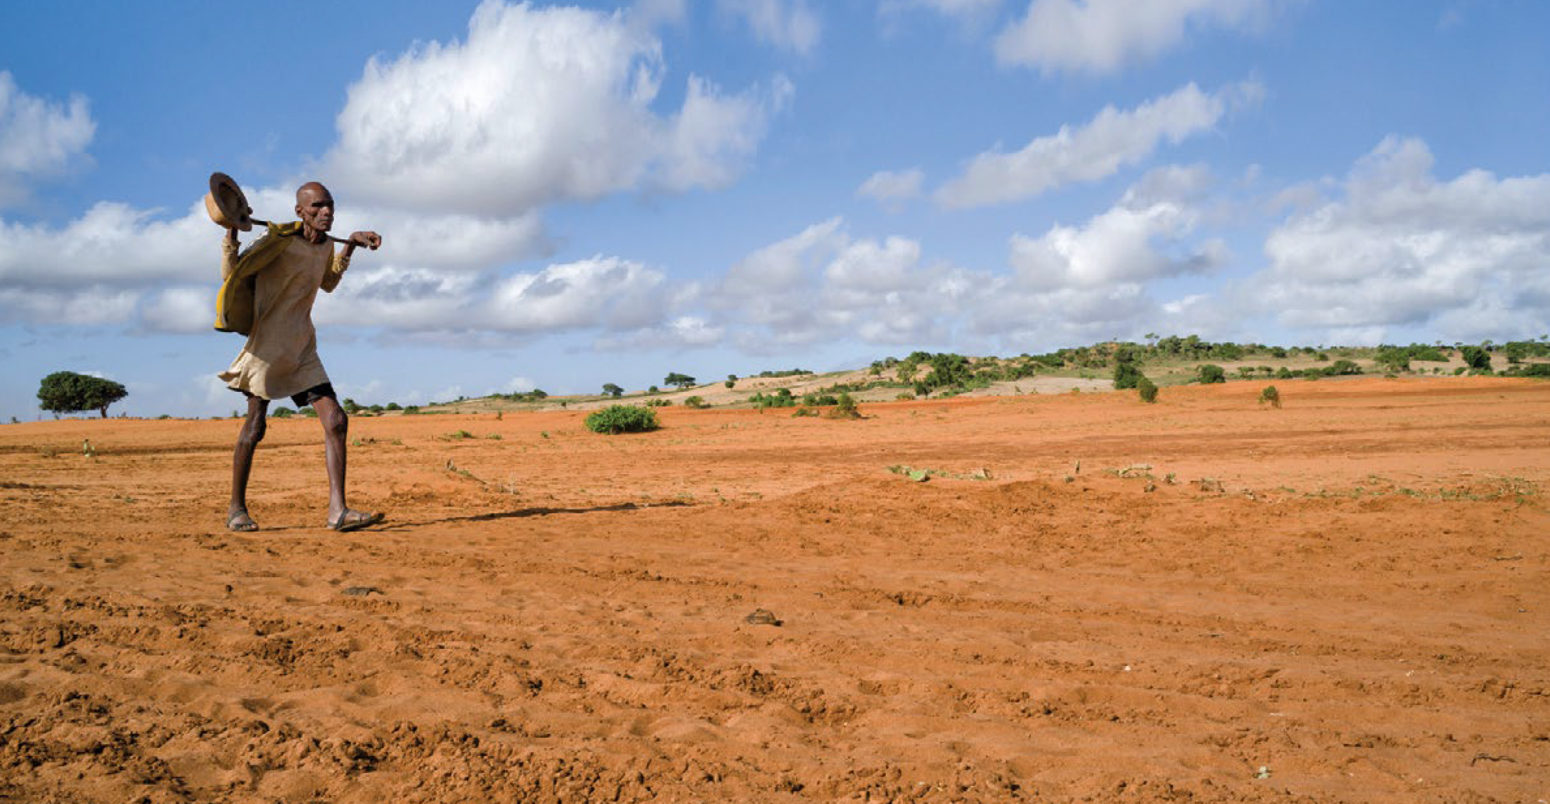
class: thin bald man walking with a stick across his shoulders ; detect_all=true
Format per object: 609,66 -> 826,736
215,181 -> 383,531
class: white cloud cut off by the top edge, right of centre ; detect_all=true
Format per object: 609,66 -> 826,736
995,0 -> 1277,74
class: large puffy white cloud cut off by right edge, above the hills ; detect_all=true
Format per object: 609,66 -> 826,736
1246,136 -> 1550,338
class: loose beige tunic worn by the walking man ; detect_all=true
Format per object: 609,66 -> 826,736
219,235 -> 349,400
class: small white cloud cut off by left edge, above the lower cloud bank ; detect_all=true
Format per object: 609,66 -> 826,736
0,70 -> 96,208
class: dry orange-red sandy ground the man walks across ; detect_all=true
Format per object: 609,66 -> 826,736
0,378 -> 1550,802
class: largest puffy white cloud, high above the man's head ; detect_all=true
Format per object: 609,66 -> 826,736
324,0 -> 791,217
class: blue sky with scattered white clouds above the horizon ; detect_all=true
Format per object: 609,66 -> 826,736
0,0 -> 1550,420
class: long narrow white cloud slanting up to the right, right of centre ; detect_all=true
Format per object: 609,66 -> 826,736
936,82 -> 1263,208
